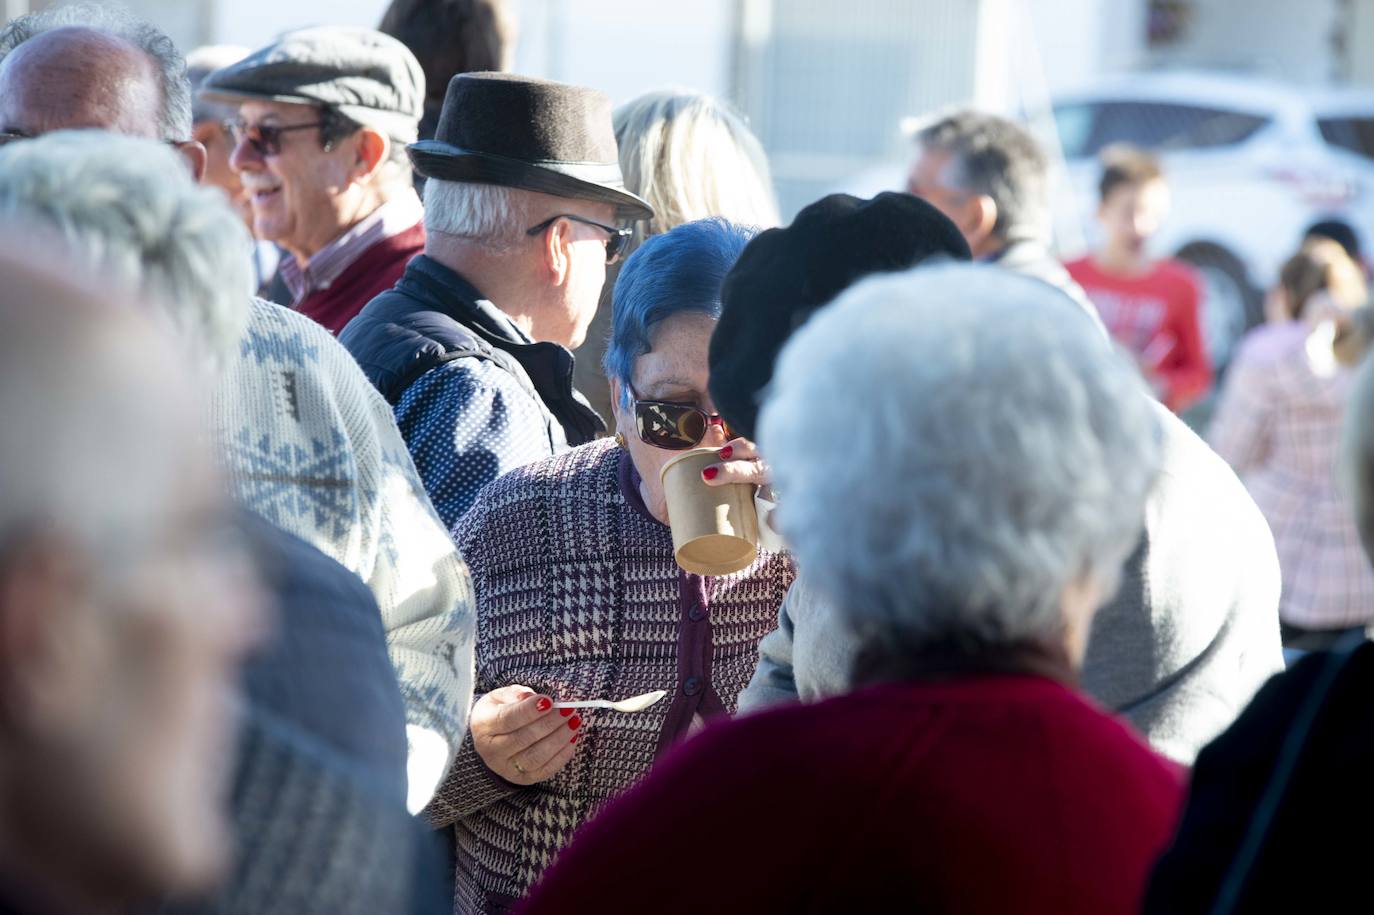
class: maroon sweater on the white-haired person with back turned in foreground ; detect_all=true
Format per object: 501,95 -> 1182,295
518,675 -> 1183,915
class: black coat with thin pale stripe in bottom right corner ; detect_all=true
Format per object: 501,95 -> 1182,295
1145,642 -> 1374,915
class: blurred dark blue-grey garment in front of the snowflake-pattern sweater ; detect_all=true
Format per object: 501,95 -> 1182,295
149,511 -> 451,915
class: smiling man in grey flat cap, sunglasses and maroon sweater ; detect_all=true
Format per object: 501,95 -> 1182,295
201,26 -> 425,334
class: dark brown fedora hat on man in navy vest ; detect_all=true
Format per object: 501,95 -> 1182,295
407,73 -> 654,220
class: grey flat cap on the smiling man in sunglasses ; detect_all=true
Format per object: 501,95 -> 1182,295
201,26 -> 425,143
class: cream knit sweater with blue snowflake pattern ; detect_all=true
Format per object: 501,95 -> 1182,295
210,300 -> 474,811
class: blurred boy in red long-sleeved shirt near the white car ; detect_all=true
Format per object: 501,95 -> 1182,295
1065,148 -> 1212,412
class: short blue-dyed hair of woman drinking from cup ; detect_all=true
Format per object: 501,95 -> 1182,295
602,217 -> 756,405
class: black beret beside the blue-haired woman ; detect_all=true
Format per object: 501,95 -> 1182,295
710,192 -> 971,438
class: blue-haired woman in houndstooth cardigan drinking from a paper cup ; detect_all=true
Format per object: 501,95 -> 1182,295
431,220 -> 793,912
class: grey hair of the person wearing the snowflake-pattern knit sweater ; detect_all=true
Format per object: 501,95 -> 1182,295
0,131 -> 251,372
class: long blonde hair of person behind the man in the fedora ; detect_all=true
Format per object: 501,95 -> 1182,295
614,91 -> 778,241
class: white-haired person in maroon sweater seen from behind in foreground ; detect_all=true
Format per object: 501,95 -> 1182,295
522,265 -> 1182,915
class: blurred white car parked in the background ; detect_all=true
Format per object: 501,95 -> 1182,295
1054,73 -> 1374,367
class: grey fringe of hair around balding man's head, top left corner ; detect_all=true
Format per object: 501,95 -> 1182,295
0,0 -> 191,142
